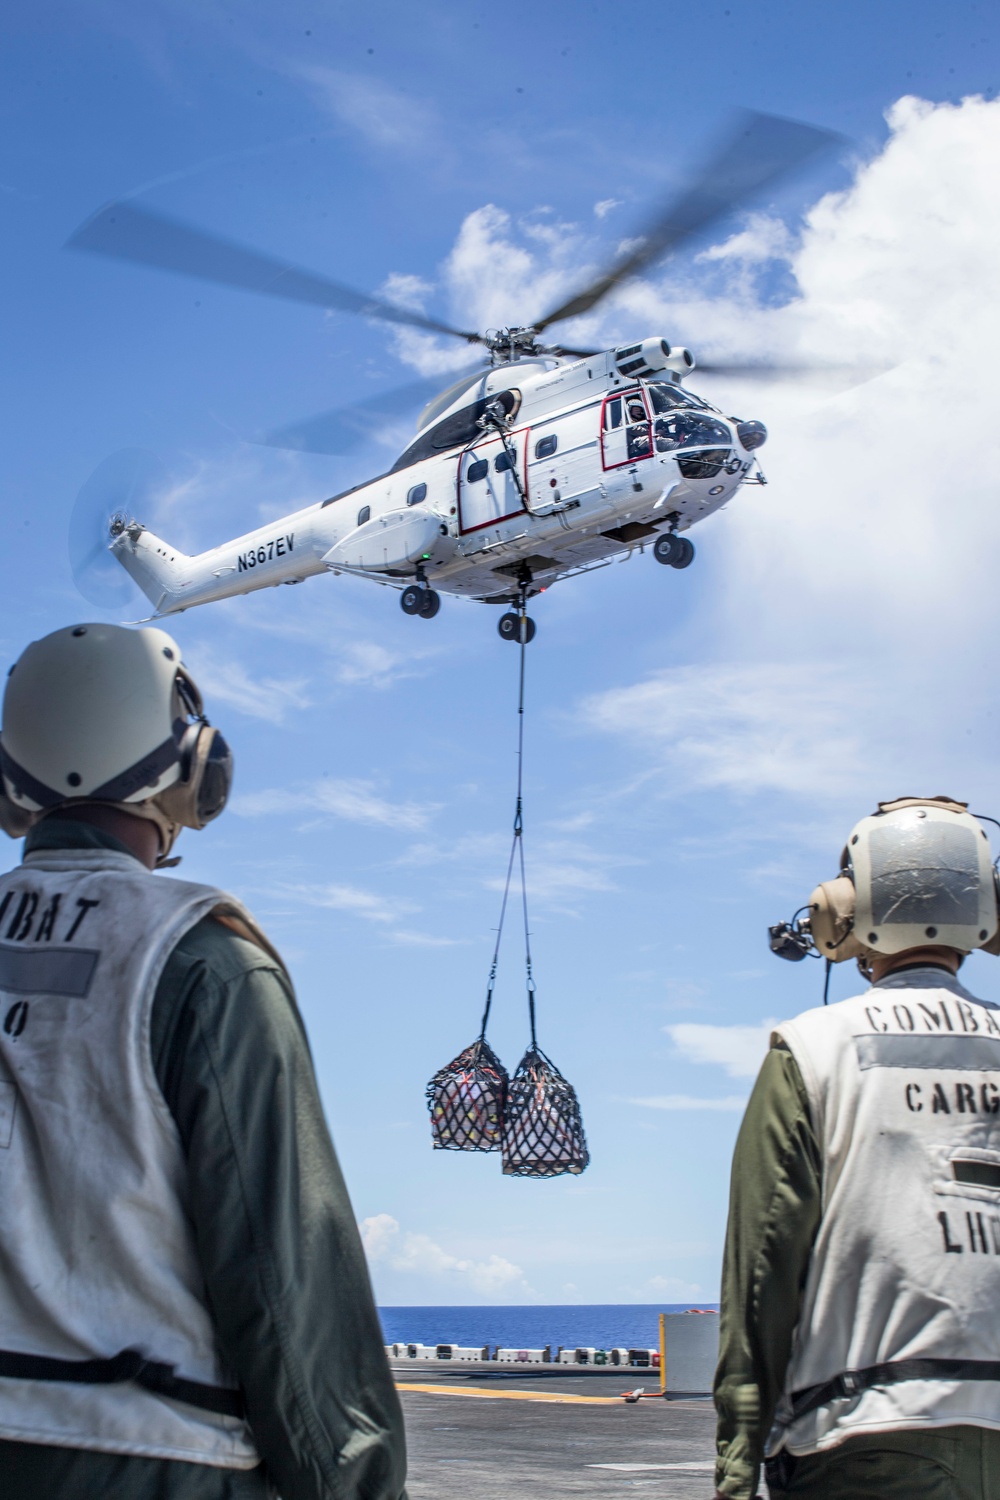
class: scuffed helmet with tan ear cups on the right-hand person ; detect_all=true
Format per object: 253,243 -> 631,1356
771,797 -> 1000,965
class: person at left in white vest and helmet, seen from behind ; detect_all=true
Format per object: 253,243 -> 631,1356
0,624 -> 405,1500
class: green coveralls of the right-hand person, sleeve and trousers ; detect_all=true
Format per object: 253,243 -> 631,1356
715,1014 -> 1000,1500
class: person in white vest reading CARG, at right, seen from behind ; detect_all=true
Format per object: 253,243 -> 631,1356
715,798 -> 1000,1500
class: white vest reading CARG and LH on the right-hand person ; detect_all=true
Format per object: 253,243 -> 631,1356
763,968 -> 1000,1454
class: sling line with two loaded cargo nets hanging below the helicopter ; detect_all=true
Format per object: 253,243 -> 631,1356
427,584 -> 591,1178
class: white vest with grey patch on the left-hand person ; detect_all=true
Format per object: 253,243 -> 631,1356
0,849 -> 259,1469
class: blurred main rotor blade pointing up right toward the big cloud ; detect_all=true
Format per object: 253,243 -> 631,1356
534,111 -> 841,332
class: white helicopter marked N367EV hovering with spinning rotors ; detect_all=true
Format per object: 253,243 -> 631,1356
69,114 -> 835,641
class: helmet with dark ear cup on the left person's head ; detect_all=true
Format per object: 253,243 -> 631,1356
0,624 -> 232,860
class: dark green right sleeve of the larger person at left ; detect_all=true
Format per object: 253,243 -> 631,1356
151,918 -> 406,1500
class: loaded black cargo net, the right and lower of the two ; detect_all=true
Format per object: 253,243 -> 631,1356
502,1043 -> 591,1178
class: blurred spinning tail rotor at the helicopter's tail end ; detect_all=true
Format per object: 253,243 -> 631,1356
69,449 -> 166,609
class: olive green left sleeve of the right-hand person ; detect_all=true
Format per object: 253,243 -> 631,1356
715,1046 -> 822,1500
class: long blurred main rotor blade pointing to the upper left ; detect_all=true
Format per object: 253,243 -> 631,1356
66,203 -> 483,344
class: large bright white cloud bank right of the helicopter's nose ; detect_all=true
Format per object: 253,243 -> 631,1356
554,98 -> 1000,806
